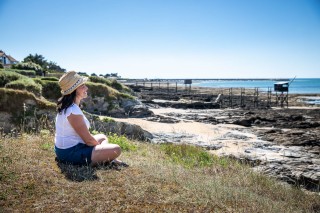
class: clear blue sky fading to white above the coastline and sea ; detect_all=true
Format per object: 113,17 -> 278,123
0,0 -> 320,78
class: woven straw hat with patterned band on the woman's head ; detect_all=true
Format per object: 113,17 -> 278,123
59,71 -> 88,95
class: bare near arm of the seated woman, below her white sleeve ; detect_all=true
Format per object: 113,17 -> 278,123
68,114 -> 100,146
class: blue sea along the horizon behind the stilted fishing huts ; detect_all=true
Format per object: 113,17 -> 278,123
192,78 -> 320,105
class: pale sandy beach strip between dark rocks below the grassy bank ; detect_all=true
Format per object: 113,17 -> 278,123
115,108 -> 258,156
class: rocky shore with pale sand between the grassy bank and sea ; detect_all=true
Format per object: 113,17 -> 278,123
118,85 -> 320,192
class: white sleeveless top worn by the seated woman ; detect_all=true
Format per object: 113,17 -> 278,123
54,104 -> 90,149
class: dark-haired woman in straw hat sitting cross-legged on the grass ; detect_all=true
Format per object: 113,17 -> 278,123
55,71 -> 126,165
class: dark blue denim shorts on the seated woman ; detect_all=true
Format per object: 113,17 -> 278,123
55,143 -> 94,165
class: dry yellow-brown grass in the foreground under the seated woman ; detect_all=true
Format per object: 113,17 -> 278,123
0,133 -> 320,212
